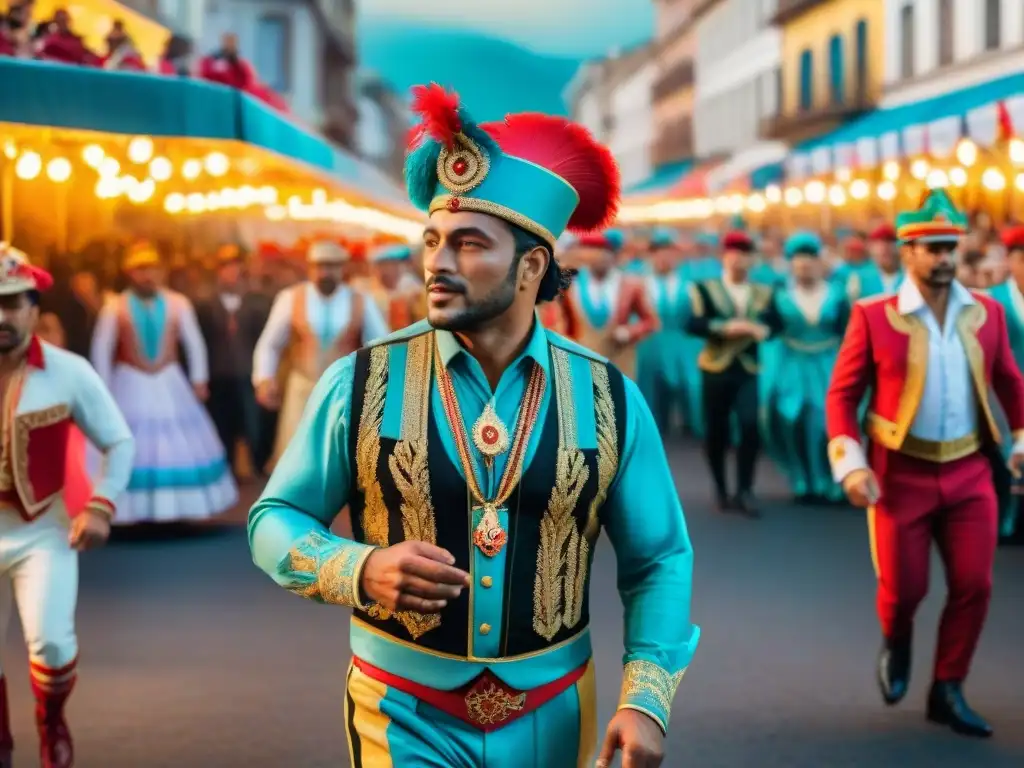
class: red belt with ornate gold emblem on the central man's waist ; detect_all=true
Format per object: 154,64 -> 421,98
352,656 -> 590,732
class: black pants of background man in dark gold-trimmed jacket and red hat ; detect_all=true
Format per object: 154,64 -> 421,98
703,364 -> 761,499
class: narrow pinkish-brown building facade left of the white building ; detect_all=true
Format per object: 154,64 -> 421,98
651,0 -> 703,168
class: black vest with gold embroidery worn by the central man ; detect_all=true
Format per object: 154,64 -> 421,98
349,331 -> 626,656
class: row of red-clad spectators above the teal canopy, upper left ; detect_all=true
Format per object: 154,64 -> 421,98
0,0 -> 288,112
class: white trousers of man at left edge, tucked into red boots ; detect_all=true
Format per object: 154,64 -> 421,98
0,502 -> 78,674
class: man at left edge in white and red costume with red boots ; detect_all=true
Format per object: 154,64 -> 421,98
0,244 -> 133,768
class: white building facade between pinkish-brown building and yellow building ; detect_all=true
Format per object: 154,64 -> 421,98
693,0 -> 785,186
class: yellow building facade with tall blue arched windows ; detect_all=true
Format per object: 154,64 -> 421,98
763,0 -> 884,143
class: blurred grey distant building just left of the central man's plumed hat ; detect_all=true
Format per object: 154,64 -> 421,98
355,73 -> 412,183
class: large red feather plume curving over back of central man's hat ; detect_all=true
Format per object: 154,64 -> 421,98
480,113 -> 621,232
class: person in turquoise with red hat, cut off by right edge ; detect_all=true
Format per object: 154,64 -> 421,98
988,226 -> 1024,545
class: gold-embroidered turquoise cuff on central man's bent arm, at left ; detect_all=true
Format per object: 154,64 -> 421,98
279,530 -> 377,609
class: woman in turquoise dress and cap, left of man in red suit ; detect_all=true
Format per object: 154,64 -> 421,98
759,232 -> 850,503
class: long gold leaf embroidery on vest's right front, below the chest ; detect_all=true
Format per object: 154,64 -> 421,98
534,447 -> 590,641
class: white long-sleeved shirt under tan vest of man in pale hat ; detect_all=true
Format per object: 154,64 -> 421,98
253,283 -> 390,382
